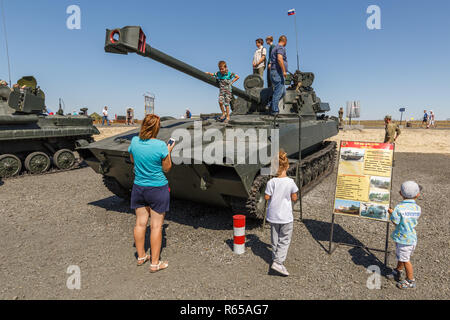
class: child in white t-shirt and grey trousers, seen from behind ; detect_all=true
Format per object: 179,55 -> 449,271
265,150 -> 298,276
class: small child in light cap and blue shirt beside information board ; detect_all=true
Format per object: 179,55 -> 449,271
388,181 -> 421,289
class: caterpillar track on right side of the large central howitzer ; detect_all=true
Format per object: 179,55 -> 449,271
228,141 -> 336,220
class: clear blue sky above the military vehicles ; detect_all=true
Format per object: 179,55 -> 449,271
0,0 -> 450,120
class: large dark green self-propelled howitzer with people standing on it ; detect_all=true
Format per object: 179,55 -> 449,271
77,26 -> 338,218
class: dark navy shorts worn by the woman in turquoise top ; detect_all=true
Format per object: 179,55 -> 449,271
131,184 -> 170,213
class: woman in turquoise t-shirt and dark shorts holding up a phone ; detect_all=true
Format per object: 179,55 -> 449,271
128,114 -> 175,272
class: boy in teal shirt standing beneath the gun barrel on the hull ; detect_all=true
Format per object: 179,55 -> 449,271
206,61 -> 239,123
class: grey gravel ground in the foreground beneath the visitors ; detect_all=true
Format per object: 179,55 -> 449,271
0,153 -> 450,299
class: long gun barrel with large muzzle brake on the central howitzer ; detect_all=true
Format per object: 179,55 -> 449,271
105,26 -> 260,103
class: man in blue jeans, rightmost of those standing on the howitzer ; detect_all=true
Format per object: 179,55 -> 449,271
270,35 -> 288,116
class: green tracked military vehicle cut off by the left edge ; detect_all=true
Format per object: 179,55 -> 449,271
0,76 -> 100,178
